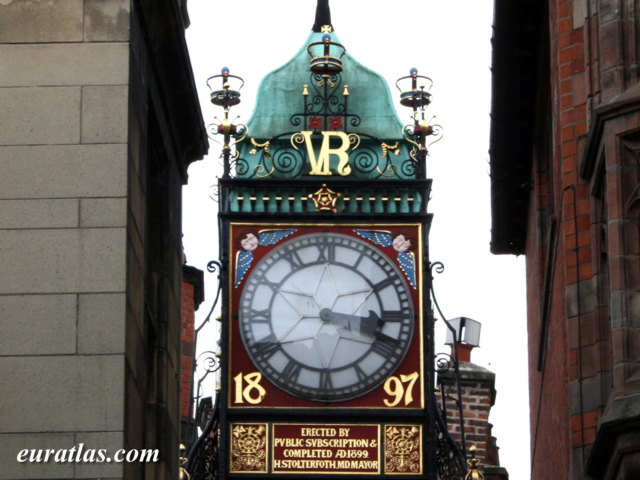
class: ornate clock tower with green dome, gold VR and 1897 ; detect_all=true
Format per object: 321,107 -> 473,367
202,0 -> 448,480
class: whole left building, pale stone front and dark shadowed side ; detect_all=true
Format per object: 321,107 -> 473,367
0,0 -> 208,479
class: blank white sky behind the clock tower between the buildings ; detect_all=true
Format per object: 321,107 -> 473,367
183,0 -> 530,480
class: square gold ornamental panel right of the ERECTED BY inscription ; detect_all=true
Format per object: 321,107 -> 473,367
384,425 -> 422,474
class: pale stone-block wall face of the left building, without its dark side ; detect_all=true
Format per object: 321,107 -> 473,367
0,0 -> 129,478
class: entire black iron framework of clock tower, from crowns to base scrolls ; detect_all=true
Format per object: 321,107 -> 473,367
188,16 -> 466,480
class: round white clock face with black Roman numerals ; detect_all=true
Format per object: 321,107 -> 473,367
238,232 -> 414,402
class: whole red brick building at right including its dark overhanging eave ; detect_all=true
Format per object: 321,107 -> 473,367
491,0 -> 640,480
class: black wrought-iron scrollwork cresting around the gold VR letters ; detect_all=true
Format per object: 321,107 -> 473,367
209,72 -> 441,184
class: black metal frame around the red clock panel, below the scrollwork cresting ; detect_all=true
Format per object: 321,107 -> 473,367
189,164 -> 466,480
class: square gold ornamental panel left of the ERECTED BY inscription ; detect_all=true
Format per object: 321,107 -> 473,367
231,423 -> 268,473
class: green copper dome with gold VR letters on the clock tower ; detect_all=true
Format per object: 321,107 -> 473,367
236,26 -> 416,184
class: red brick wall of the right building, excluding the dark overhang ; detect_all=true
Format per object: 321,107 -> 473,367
527,0 -> 640,479
